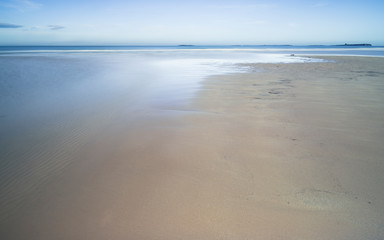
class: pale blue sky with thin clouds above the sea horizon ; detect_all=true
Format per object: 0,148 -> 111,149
0,0 -> 384,45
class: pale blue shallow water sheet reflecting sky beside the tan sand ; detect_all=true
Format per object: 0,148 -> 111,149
0,50 -> 324,118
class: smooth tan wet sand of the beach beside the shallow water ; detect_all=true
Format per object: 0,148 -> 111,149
0,56 -> 384,240
